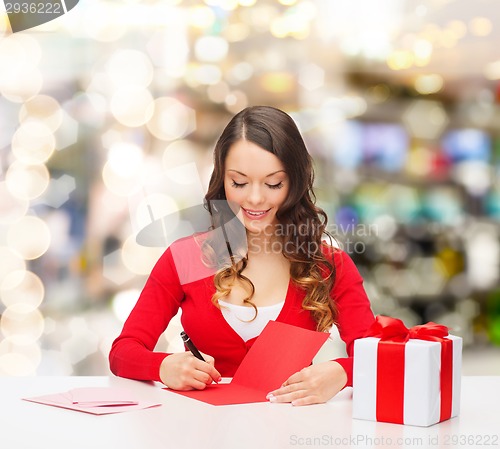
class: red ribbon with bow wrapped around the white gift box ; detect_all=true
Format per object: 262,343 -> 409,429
365,315 -> 453,424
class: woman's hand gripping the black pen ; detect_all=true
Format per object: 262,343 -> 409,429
160,351 -> 221,390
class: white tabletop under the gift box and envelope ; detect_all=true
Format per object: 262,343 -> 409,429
0,377 -> 500,449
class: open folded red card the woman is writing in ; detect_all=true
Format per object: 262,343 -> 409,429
170,321 -> 330,405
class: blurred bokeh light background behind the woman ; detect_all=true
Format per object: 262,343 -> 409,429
0,0 -> 500,375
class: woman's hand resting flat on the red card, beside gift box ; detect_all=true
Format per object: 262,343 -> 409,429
266,361 -> 347,405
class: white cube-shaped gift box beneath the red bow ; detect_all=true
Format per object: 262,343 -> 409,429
353,335 -> 462,426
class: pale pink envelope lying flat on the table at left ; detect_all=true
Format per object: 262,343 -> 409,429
24,387 -> 161,415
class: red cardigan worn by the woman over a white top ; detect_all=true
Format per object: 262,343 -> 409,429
109,238 -> 374,386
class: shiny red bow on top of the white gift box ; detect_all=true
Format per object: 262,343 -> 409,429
365,315 -> 448,342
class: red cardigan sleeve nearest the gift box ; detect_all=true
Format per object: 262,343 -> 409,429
331,250 -> 375,387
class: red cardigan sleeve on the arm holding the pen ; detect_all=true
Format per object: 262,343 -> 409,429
109,248 -> 184,381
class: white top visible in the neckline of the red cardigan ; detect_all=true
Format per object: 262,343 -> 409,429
219,299 -> 285,341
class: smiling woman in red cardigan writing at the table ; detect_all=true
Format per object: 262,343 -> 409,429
110,106 -> 374,405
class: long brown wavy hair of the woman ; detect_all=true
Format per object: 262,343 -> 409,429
205,106 -> 337,331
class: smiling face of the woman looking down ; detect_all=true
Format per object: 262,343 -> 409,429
224,139 -> 289,234
